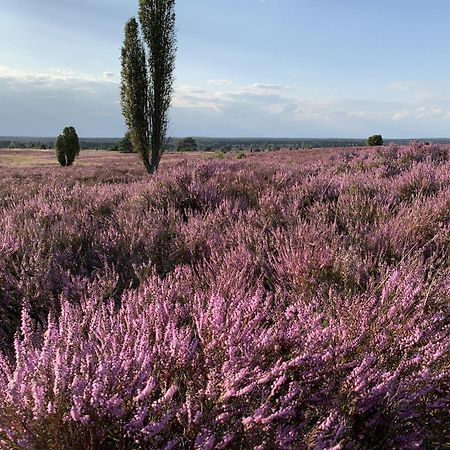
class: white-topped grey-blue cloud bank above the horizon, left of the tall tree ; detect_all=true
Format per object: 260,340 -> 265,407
0,66 -> 123,136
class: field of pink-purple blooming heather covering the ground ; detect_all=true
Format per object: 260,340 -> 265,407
0,143 -> 450,450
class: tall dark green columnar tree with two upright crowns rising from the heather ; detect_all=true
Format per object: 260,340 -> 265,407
121,0 -> 176,173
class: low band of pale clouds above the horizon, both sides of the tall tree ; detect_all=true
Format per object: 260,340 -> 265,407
0,66 -> 450,137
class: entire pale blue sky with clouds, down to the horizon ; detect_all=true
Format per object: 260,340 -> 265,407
0,0 -> 450,138
